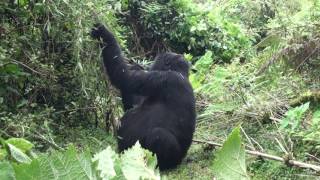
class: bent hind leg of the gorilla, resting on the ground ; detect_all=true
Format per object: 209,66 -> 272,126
142,128 -> 182,170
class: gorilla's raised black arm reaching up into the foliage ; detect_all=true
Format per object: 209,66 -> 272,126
91,24 -> 170,96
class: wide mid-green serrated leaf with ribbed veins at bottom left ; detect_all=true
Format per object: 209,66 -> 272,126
14,147 -> 97,180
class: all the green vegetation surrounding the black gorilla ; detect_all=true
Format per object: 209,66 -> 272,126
0,0 -> 320,180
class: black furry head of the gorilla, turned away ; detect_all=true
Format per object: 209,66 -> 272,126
150,52 -> 190,77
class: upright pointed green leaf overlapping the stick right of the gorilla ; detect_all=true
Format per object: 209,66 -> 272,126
213,127 -> 249,180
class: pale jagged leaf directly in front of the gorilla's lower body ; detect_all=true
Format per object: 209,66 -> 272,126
121,142 -> 160,180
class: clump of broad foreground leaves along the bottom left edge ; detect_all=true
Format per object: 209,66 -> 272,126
0,138 -> 160,180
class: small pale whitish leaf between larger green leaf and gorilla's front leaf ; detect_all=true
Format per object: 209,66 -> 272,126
92,146 -> 118,180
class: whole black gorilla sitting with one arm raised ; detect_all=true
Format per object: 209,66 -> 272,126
91,24 -> 196,170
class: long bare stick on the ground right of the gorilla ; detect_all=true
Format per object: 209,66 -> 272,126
193,139 -> 320,172
